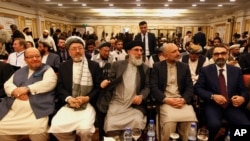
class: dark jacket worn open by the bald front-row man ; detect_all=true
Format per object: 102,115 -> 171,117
150,60 -> 194,104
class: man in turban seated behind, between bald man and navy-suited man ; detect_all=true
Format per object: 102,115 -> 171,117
181,44 -> 209,84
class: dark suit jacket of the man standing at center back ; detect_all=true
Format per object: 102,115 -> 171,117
135,32 -> 156,55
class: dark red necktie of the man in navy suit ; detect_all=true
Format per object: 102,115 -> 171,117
219,69 -> 228,108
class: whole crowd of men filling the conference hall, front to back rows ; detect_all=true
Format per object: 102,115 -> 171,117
0,21 -> 250,141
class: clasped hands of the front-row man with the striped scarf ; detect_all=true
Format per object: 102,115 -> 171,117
67,96 -> 89,108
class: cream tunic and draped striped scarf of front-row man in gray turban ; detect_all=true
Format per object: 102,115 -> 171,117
49,58 -> 96,133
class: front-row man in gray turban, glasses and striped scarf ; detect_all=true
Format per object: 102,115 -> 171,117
49,36 -> 102,141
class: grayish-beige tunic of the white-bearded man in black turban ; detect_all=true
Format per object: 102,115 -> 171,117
104,63 -> 146,132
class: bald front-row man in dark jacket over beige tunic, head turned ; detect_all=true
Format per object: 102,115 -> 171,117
150,43 -> 197,141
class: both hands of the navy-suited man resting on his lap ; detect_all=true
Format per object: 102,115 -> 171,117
213,94 -> 245,107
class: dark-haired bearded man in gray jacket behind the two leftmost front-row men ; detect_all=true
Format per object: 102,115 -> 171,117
38,42 -> 60,71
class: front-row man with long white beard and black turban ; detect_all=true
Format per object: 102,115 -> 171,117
97,41 -> 149,136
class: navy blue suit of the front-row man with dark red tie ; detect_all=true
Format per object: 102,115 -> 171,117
194,64 -> 250,139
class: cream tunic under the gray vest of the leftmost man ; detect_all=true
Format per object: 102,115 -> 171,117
0,68 -> 57,135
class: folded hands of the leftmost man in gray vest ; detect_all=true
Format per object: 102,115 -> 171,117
11,87 -> 29,100
